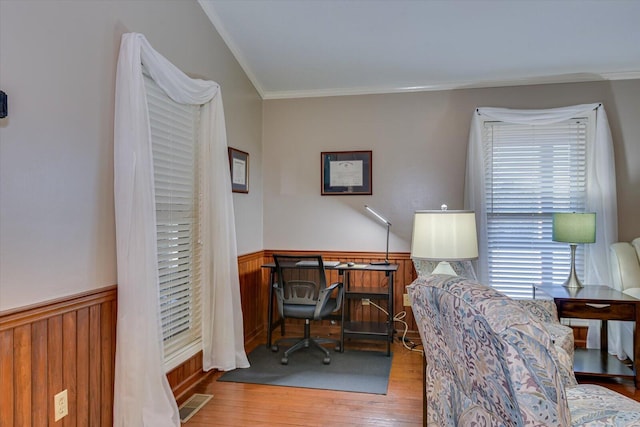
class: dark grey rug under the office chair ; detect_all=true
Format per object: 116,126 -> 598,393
218,345 -> 393,394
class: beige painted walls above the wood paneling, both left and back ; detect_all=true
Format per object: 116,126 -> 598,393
0,0 -> 640,310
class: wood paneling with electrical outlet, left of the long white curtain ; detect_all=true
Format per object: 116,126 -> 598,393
0,286 -> 116,427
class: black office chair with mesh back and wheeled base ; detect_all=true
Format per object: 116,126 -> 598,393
271,254 -> 343,365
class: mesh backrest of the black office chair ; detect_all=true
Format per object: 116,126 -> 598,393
273,254 -> 327,305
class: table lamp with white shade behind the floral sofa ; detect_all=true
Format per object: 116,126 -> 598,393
411,205 -> 478,276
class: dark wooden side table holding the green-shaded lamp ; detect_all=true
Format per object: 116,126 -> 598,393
534,285 -> 640,388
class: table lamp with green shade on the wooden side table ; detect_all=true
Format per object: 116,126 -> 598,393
551,212 -> 596,288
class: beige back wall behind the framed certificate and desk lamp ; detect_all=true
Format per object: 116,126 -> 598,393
263,80 -> 640,251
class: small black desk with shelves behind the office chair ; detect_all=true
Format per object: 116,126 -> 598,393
262,263 -> 398,355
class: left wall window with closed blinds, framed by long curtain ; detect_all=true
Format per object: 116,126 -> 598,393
145,76 -> 201,370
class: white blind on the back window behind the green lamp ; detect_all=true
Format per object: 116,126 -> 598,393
483,118 -> 589,298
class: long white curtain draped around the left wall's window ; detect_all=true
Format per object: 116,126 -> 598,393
114,33 -> 249,427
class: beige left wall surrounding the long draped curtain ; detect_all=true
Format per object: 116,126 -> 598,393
0,0 -> 263,310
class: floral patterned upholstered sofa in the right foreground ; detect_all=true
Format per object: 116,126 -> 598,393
408,275 -> 640,427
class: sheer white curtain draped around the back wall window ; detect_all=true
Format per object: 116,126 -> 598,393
465,104 -> 623,356
